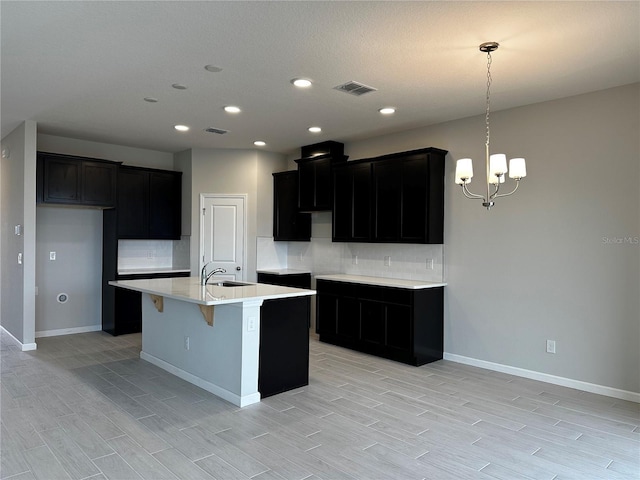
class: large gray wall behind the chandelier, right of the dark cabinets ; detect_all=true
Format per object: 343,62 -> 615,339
345,84 -> 640,392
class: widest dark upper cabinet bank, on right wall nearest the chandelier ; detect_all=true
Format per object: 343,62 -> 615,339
333,148 -> 447,243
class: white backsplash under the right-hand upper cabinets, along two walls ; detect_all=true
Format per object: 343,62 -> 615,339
257,237 -> 445,282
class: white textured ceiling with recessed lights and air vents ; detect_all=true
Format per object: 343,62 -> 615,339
0,0 -> 640,153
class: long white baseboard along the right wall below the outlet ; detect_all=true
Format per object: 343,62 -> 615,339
444,353 -> 640,403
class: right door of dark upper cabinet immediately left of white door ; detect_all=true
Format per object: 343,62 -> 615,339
148,171 -> 182,240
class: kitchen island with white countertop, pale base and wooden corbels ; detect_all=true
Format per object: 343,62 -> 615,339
109,277 -> 315,407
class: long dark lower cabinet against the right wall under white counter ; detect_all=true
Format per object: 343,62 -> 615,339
316,279 -> 444,365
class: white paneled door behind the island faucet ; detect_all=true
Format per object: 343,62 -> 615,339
200,194 -> 246,280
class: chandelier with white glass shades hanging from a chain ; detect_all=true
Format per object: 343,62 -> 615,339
455,42 -> 527,210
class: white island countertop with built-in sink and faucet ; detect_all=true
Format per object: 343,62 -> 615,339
109,277 -> 316,305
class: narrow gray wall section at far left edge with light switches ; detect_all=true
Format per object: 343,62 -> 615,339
0,121 -> 36,349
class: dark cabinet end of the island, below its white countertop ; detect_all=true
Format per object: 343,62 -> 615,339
258,296 -> 311,398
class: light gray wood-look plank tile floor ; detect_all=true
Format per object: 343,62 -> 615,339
0,332 -> 640,480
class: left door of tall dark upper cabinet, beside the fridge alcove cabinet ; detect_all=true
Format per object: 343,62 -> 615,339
117,167 -> 149,239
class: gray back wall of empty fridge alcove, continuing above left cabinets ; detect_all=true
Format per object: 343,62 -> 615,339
33,134 -> 180,335
